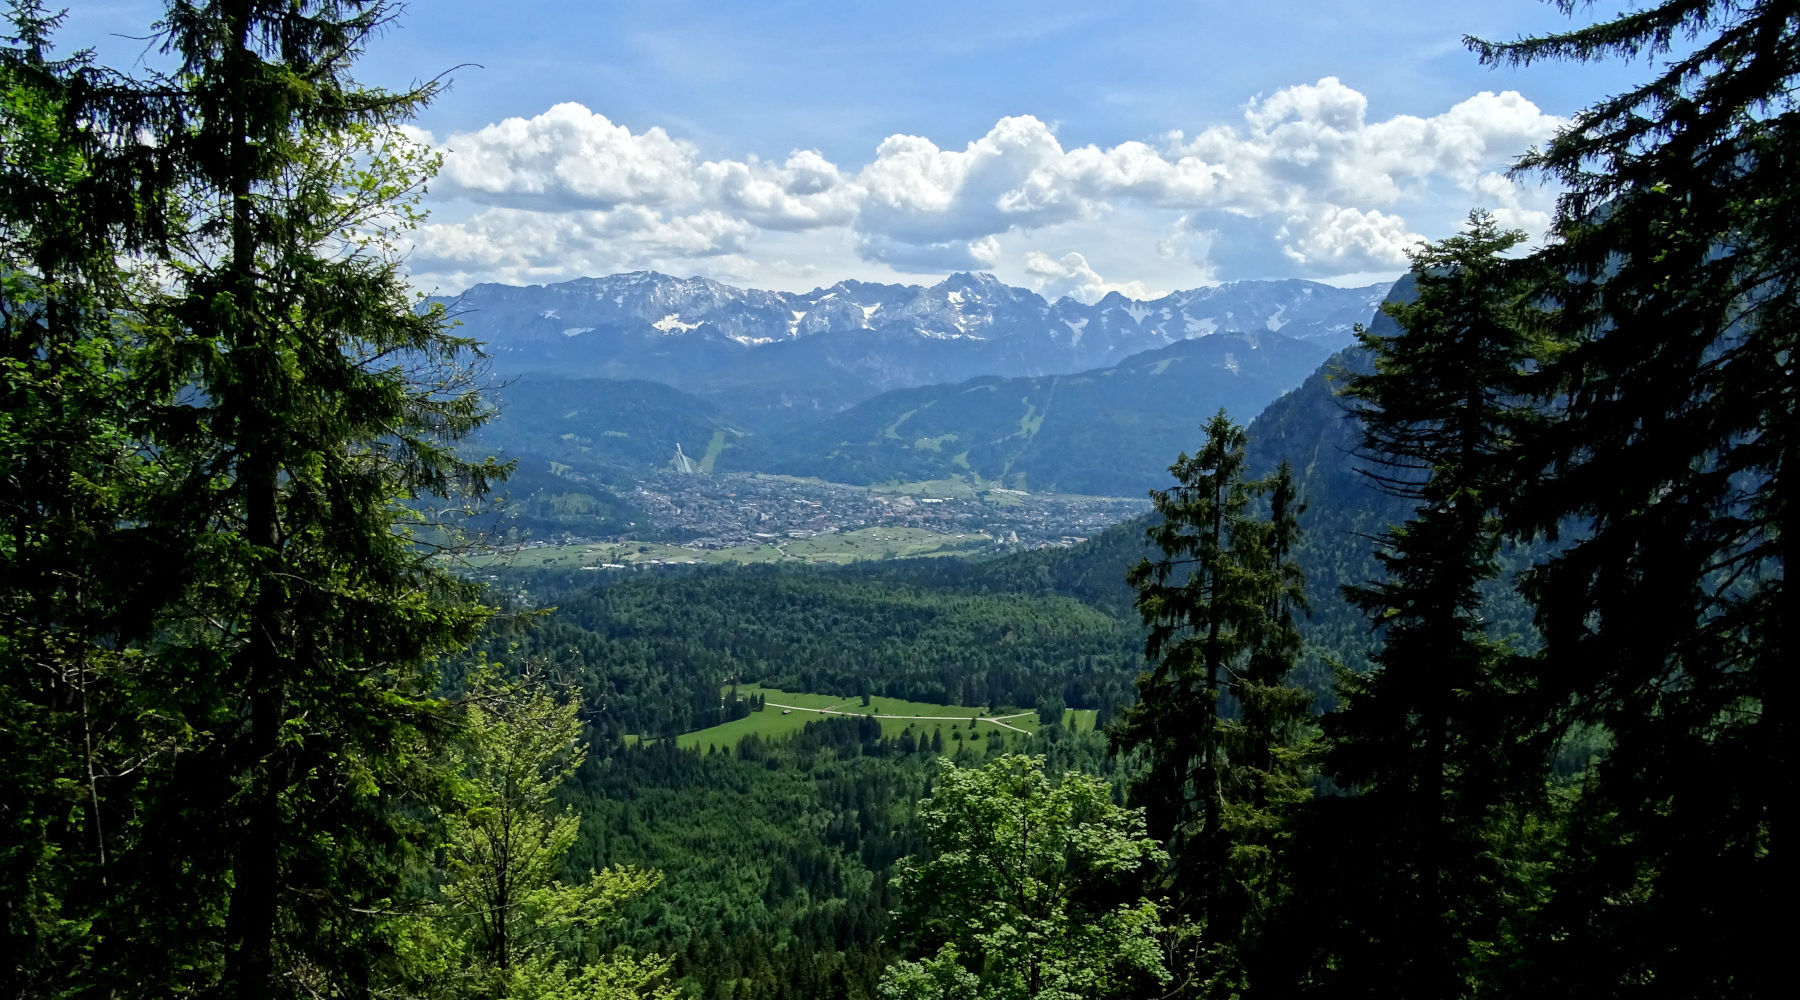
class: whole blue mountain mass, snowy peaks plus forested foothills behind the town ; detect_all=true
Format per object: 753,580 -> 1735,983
457,272 -> 1388,496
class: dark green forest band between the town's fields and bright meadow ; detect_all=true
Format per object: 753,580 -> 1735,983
477,567 -> 1141,736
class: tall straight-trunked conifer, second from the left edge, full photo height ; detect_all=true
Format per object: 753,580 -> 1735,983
151,0 -> 488,996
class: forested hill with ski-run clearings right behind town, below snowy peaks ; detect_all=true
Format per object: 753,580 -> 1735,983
722,333 -> 1328,496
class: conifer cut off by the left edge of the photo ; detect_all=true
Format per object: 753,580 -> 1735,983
0,0 -> 182,996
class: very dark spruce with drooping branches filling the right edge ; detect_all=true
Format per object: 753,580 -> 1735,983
1472,0 -> 1800,996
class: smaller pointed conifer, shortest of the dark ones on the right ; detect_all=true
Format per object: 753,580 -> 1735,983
1112,410 -> 1307,991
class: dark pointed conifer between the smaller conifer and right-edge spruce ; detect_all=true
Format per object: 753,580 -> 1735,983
1318,212 -> 1539,998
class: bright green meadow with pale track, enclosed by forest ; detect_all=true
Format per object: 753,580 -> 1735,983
675,687 -> 1094,748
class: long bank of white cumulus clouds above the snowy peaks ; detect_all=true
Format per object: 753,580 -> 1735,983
408,77 -> 1561,295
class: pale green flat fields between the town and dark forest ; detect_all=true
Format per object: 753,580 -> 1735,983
468,527 -> 994,572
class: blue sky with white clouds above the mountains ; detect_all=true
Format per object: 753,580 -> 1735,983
61,0 -> 1647,300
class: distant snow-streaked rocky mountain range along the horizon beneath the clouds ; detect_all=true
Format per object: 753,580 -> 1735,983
439,272 -> 1386,419
